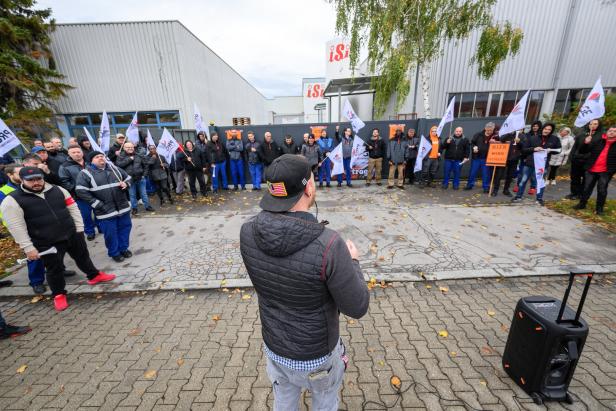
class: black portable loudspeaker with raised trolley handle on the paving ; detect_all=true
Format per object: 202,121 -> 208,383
503,270 -> 594,404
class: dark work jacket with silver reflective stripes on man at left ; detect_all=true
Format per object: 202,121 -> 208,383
75,164 -> 131,220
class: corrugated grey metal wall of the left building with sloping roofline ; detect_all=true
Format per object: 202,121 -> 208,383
51,21 -> 267,128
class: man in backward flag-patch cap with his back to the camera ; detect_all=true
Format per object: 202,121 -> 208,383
240,154 -> 370,410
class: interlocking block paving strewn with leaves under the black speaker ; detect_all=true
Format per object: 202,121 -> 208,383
0,276 -> 616,411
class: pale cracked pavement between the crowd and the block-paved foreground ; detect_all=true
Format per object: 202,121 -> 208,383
0,181 -> 616,296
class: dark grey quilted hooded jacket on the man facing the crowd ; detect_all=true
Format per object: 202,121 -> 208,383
240,211 -> 370,361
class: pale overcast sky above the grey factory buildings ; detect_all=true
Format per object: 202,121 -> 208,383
37,0 -> 336,97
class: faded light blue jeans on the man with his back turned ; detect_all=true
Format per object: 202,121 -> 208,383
266,341 -> 346,411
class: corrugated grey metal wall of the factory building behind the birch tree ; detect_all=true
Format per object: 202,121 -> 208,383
404,0 -> 616,117
